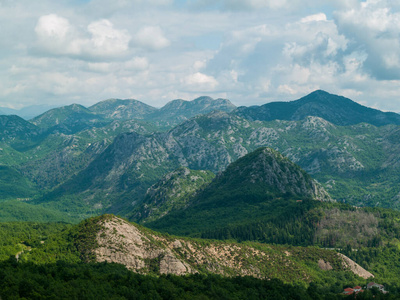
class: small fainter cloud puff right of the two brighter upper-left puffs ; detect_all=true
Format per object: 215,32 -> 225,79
133,26 -> 171,50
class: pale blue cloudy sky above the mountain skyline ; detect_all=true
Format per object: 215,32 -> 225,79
0,0 -> 400,112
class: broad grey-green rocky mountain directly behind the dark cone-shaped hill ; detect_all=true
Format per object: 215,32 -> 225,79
32,107 -> 400,218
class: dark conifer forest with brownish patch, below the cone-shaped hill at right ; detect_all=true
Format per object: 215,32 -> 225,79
201,200 -> 400,248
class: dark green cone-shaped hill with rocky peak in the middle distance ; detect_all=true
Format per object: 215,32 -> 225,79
148,148 -> 331,236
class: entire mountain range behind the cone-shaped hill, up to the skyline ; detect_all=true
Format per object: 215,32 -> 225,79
0,91 -> 400,218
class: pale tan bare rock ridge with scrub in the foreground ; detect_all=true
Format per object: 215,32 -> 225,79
89,215 -> 374,281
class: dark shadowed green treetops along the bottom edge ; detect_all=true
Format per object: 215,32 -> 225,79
0,258 -> 396,300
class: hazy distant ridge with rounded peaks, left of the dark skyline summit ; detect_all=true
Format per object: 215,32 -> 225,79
31,96 -> 236,133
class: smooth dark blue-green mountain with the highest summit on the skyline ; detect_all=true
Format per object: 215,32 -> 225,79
235,90 -> 400,126
